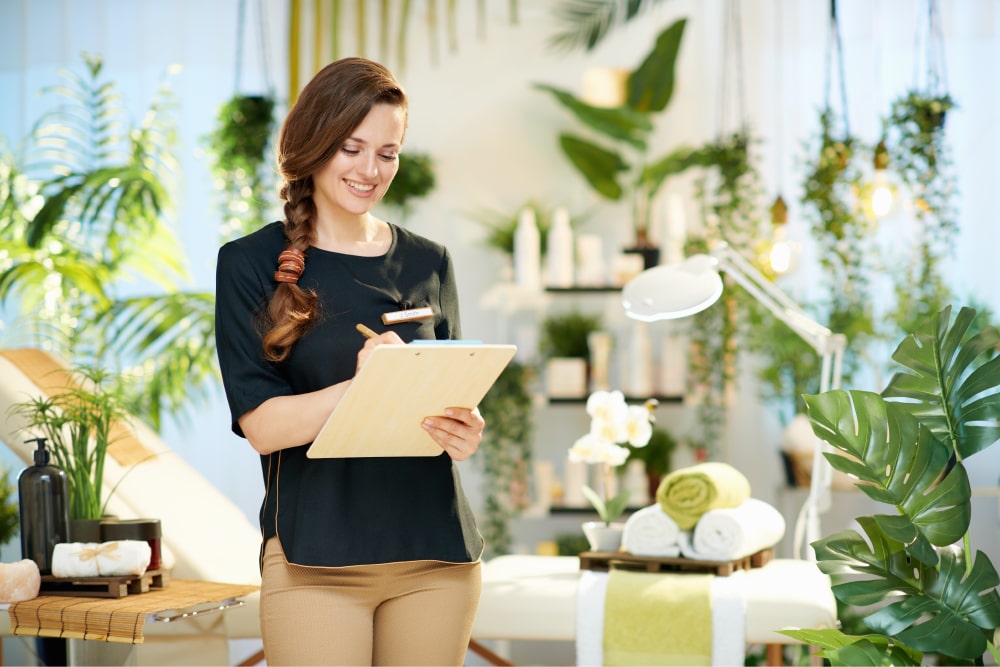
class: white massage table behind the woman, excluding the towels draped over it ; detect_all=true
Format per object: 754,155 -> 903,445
472,555 -> 837,665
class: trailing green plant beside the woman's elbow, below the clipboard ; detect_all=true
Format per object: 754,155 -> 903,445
473,361 -> 535,559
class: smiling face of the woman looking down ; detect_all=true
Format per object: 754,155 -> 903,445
313,104 -> 406,215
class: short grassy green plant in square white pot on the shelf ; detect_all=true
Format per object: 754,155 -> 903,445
539,309 -> 602,398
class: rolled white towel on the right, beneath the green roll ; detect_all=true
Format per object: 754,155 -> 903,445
679,498 -> 785,561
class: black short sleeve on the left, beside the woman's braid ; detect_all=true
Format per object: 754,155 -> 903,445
215,242 -> 294,437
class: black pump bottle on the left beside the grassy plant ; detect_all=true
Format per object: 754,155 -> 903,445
17,438 -> 69,574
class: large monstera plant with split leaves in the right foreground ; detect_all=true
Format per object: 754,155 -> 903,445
783,306 -> 1000,665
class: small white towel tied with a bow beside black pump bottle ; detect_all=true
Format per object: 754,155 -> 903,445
52,540 -> 152,578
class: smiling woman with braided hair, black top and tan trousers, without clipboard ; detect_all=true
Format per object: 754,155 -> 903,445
216,58 -> 484,665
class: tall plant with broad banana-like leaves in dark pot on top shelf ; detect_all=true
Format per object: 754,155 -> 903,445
536,19 -> 697,267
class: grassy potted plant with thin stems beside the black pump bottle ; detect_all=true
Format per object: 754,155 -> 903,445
11,366 -> 129,542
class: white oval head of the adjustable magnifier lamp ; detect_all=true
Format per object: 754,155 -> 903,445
622,255 -> 722,322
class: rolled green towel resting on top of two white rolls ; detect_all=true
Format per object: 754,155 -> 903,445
656,461 -> 750,530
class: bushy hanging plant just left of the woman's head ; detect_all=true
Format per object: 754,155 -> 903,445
205,94 -> 275,240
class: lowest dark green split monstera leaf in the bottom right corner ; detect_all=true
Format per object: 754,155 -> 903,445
814,517 -> 1000,660
